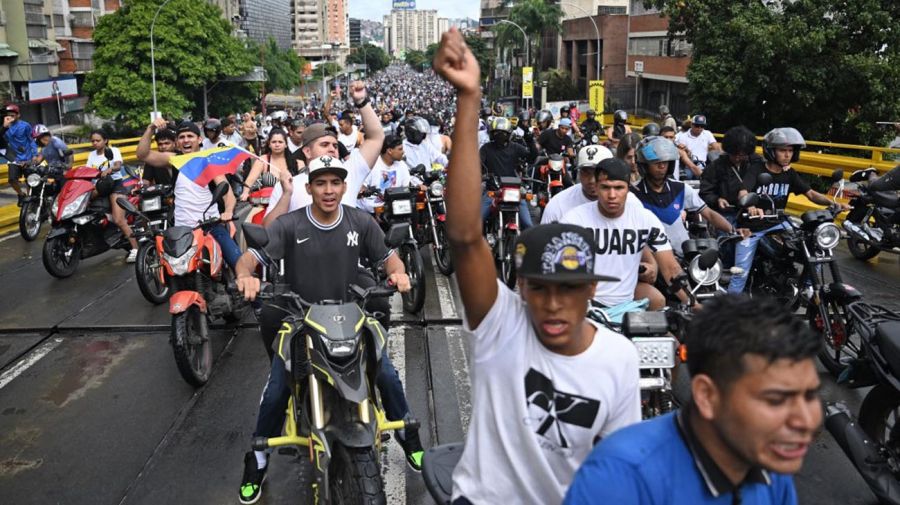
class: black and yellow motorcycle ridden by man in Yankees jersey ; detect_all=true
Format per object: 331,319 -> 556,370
244,224 -> 419,504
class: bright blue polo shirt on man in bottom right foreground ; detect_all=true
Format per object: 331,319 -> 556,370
563,411 -> 797,505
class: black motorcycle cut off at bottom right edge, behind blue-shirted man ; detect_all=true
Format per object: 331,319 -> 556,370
825,302 -> 900,505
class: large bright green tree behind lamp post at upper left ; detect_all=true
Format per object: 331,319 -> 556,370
84,0 -> 253,128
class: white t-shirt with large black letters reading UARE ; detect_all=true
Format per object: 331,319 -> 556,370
560,200 -> 672,307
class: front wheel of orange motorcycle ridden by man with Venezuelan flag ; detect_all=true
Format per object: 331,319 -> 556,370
172,305 -> 212,387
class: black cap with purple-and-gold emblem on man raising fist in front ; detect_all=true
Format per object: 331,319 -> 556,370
516,223 -> 619,282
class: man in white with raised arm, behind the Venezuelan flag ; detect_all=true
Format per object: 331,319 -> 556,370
136,119 -> 241,269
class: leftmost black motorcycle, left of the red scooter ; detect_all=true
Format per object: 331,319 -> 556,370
19,160 -> 71,242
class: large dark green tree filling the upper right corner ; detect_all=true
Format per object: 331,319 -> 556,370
647,0 -> 900,143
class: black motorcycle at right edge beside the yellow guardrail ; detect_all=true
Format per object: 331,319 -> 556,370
844,165 -> 900,261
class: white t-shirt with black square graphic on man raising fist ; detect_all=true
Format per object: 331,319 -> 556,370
453,282 -> 641,505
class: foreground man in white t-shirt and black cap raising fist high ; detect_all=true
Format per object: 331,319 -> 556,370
434,28 -> 640,505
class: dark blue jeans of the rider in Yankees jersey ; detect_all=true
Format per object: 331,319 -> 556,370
253,342 -> 409,438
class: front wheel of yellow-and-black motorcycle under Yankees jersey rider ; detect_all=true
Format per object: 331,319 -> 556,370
328,443 -> 387,505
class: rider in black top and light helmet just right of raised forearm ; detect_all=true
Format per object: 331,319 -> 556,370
479,117 -> 537,230
